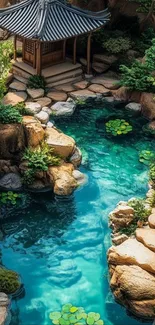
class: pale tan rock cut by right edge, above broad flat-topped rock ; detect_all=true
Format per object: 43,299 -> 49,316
136,228 -> 155,252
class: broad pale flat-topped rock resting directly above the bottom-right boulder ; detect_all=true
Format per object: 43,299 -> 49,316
108,239 -> 155,273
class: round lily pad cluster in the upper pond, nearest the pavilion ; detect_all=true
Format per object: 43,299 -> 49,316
105,119 -> 132,136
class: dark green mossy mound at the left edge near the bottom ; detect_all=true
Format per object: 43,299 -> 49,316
0,268 -> 20,294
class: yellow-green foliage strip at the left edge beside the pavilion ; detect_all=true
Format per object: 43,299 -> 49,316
0,41 -> 13,99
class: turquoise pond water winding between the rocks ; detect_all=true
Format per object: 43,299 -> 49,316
1,103 -> 153,325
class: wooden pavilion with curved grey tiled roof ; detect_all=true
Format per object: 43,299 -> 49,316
0,0 -> 110,75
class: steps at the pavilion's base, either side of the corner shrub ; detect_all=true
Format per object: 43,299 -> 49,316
12,59 -> 83,88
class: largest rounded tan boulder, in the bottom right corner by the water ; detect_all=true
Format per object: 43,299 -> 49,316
110,265 -> 155,318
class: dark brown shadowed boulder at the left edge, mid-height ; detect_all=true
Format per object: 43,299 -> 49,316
0,124 -> 25,160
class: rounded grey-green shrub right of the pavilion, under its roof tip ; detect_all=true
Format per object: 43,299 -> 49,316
103,36 -> 132,54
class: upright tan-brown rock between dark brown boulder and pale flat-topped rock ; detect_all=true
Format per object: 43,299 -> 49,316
23,116 -> 45,147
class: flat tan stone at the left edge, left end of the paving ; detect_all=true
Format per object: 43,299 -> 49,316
2,91 -> 27,106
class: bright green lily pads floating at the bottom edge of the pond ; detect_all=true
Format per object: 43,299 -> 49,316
49,303 -> 104,325
